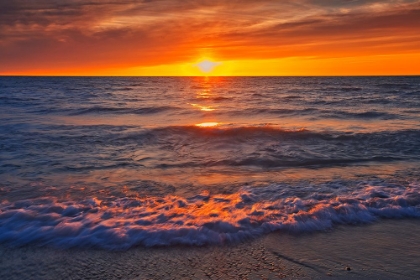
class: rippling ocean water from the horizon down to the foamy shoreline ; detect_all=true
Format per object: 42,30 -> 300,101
0,77 -> 420,249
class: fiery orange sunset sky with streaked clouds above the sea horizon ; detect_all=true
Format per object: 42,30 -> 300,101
0,0 -> 420,76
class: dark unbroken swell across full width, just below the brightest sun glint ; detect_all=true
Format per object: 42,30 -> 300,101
0,124 -> 420,174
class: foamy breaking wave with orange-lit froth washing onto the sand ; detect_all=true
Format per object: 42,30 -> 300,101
0,183 -> 420,250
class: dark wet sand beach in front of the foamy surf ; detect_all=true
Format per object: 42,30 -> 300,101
0,220 -> 420,279
